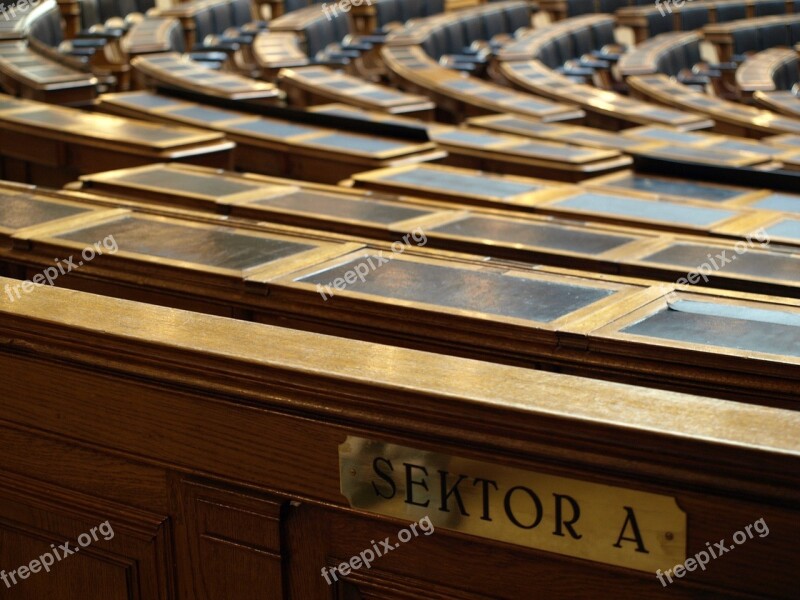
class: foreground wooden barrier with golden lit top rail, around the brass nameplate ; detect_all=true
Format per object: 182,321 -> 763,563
0,280 -> 800,600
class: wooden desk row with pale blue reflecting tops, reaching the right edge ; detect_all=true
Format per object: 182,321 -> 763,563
353,165 -> 798,240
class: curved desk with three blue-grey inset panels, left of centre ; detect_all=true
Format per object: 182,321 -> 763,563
100,92 -> 445,183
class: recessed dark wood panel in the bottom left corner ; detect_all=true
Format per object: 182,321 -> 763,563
0,474 -> 174,600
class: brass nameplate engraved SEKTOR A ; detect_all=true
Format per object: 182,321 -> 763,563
339,436 -> 686,573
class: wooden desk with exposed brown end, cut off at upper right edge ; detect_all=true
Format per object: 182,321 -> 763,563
703,14 -> 800,62
